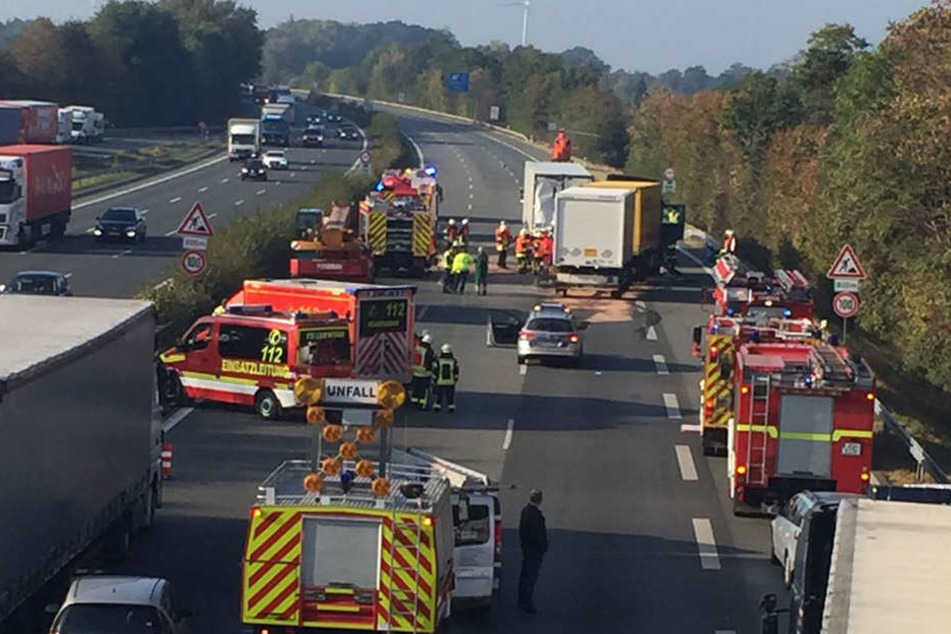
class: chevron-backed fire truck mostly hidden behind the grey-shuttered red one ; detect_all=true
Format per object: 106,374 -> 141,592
693,315 -> 822,455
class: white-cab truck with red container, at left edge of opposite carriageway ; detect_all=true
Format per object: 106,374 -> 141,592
0,145 -> 73,246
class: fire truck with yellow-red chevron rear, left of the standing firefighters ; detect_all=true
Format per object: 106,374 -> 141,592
360,168 -> 439,275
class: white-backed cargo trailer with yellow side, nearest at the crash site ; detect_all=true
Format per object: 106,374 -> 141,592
552,181 -> 663,298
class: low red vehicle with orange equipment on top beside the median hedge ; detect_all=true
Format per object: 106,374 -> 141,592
290,205 -> 373,283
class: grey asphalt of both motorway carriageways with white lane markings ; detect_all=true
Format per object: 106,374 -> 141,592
0,106 -> 781,634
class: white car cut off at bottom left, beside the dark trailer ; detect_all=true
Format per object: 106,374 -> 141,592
50,575 -> 193,634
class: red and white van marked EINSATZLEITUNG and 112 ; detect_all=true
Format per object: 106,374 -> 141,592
159,305 -> 353,419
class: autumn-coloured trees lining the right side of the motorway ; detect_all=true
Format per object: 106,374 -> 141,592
627,0 -> 951,390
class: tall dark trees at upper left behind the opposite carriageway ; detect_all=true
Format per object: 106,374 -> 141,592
0,0 -> 264,126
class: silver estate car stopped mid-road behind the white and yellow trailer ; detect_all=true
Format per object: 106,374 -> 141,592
517,303 -> 587,365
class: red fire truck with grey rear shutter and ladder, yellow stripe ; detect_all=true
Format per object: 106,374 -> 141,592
727,343 -> 875,514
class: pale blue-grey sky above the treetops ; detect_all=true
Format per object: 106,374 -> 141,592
0,0 -> 929,75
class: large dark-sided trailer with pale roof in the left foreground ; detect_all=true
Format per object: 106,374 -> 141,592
0,294 -> 162,631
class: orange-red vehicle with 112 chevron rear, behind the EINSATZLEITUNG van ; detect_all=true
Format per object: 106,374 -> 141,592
227,279 -> 416,383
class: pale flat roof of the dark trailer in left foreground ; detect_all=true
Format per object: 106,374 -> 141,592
0,293 -> 153,381
